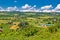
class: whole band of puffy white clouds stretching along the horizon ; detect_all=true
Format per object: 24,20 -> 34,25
0,4 -> 60,12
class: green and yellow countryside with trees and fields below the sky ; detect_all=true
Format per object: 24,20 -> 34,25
0,12 -> 60,40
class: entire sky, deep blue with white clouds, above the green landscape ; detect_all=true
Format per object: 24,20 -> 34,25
0,0 -> 60,12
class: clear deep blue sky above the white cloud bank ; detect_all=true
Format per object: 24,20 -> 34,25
0,0 -> 60,8
